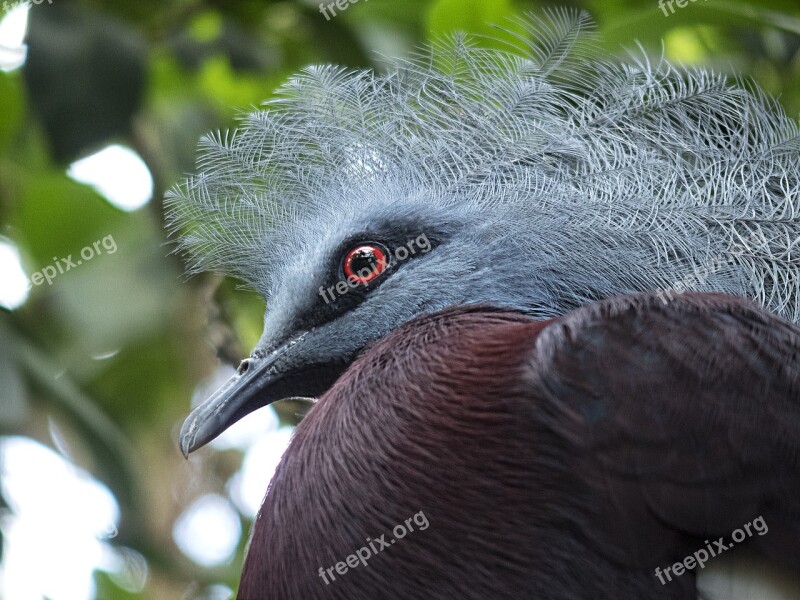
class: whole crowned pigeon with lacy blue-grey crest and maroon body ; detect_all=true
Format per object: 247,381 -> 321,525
165,9 -> 800,600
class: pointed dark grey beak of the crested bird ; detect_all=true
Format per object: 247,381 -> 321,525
180,333 -> 345,457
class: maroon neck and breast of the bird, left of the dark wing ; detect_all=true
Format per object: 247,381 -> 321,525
240,313 -> 568,600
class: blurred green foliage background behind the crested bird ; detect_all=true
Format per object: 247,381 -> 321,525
0,0 -> 800,599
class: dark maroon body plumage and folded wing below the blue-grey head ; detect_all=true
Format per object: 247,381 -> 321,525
239,294 -> 800,600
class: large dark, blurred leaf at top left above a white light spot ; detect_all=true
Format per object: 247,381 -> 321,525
23,2 -> 146,163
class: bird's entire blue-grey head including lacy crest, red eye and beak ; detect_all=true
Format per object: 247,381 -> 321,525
167,11 -> 800,453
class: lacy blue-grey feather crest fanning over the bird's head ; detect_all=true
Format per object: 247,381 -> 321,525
167,11 -> 800,321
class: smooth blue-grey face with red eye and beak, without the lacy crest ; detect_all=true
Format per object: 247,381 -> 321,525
174,179 -> 552,455
